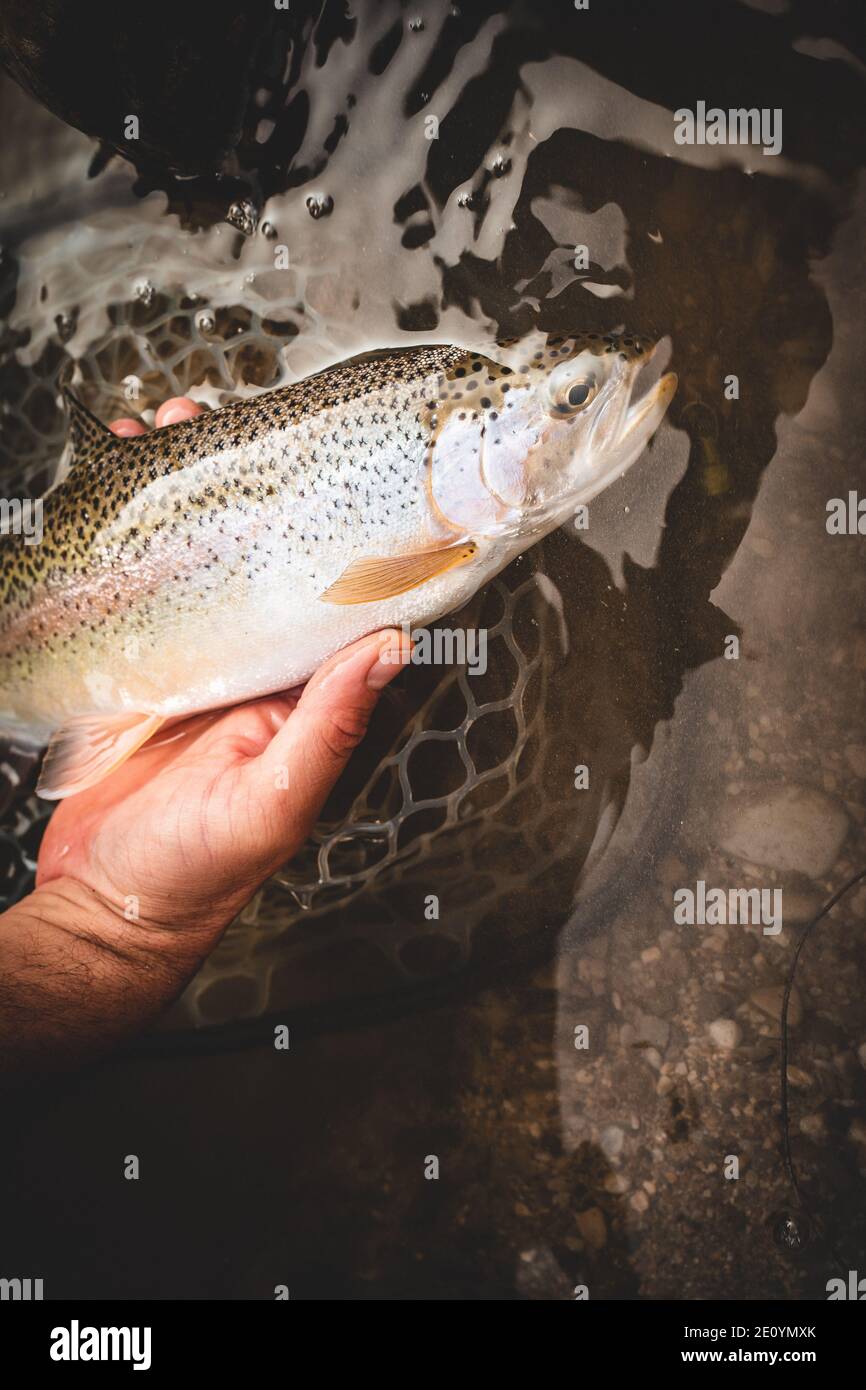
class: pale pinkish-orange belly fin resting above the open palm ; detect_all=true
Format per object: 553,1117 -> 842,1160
36,712 -> 164,801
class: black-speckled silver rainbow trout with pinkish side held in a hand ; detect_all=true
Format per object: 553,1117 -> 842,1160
0,335 -> 676,798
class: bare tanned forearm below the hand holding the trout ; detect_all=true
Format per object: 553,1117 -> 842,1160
0,878 -> 220,1086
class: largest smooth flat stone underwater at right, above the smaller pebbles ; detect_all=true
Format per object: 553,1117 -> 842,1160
719,783 -> 848,878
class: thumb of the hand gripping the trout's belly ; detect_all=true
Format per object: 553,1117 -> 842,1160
252,630 -> 411,834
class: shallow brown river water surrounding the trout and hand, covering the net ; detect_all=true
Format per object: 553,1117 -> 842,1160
0,0 -> 866,1298
